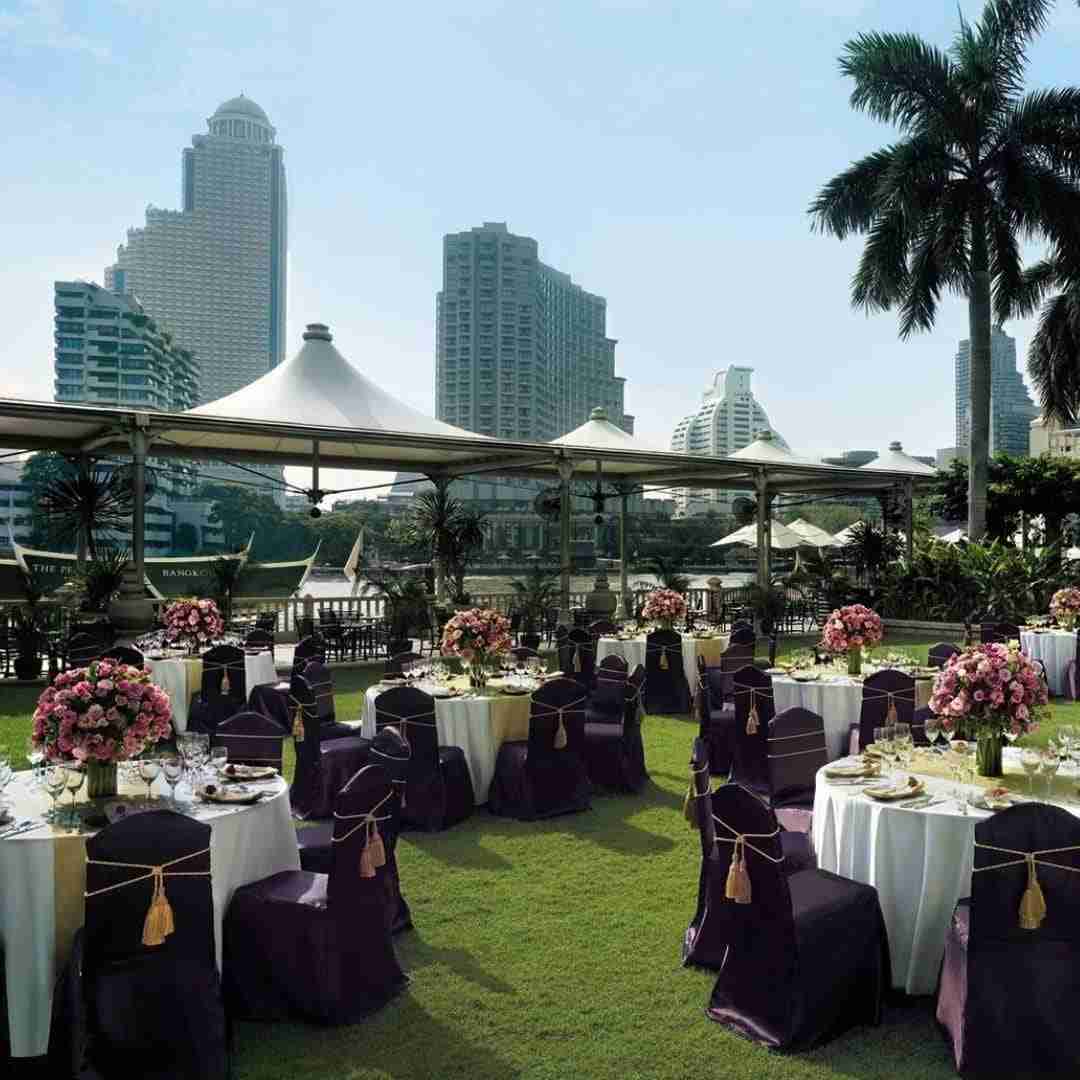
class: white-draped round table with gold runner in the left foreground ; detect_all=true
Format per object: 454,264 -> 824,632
0,772 -> 300,1057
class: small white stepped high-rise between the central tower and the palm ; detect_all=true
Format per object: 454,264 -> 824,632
671,366 -> 787,517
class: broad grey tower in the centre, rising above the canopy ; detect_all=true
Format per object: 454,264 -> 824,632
435,221 -> 634,441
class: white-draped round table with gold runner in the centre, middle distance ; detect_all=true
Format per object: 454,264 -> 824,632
361,685 -> 529,806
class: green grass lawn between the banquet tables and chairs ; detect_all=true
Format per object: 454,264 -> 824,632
0,642 -> 1080,1080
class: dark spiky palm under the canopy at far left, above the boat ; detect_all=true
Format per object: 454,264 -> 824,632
36,460 -> 135,565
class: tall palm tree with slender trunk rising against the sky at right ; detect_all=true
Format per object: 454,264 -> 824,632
809,0 -> 1080,540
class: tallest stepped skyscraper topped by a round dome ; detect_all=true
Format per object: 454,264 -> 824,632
105,95 -> 287,403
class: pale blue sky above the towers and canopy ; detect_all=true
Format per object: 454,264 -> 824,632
6,0 -> 1080,494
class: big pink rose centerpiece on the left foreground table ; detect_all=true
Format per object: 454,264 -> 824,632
31,660 -> 173,798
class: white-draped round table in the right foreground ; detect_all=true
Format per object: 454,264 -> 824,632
813,746 -> 1080,994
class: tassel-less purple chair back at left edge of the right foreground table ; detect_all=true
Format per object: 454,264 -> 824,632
766,706 -> 828,835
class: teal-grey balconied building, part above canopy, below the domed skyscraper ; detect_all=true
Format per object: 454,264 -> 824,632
53,281 -> 200,413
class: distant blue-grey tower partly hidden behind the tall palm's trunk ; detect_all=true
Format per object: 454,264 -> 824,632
956,327 -> 1039,456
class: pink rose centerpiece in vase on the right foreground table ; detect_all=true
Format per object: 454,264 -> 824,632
930,643 -> 1049,777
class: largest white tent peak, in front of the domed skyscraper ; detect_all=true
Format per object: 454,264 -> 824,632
191,323 -> 486,440
